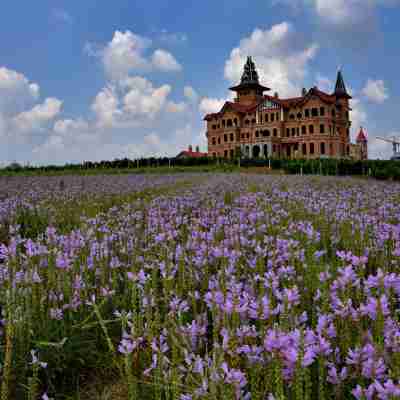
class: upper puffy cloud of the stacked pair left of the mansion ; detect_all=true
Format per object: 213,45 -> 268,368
92,30 -> 182,81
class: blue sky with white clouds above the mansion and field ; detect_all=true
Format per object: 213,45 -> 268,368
0,0 -> 400,164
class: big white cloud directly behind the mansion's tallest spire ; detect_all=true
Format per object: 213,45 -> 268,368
225,22 -> 318,97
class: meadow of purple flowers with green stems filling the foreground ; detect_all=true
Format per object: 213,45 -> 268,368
0,174 -> 400,400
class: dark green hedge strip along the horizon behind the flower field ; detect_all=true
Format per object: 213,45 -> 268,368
1,157 -> 400,181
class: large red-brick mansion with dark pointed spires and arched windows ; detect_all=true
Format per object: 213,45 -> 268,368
204,57 -> 368,160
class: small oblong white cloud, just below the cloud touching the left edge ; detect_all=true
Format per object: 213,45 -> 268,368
13,97 -> 63,133
